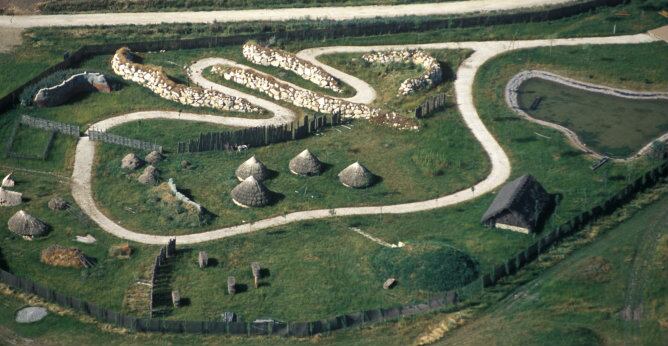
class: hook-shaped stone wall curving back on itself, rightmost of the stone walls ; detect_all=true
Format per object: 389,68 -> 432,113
362,49 -> 443,95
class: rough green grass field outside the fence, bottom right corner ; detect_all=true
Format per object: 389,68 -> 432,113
444,191 -> 668,345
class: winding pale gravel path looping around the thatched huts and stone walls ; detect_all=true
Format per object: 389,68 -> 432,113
72,34 -> 657,244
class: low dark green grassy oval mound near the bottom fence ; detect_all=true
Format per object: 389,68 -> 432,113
371,242 -> 478,292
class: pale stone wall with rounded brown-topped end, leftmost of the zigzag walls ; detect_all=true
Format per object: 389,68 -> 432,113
111,48 -> 260,112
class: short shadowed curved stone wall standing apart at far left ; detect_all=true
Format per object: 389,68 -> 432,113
33,72 -> 111,107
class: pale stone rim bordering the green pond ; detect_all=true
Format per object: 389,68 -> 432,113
505,70 -> 668,162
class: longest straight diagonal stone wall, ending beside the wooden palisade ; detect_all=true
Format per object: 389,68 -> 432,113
211,65 -> 418,130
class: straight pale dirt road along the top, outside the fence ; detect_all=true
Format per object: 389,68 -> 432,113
0,0 -> 577,28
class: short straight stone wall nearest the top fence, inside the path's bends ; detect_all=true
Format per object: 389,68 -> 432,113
242,42 -> 342,93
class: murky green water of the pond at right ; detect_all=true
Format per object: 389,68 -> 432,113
518,78 -> 668,157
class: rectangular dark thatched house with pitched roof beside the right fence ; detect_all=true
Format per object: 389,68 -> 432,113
481,174 -> 552,233
